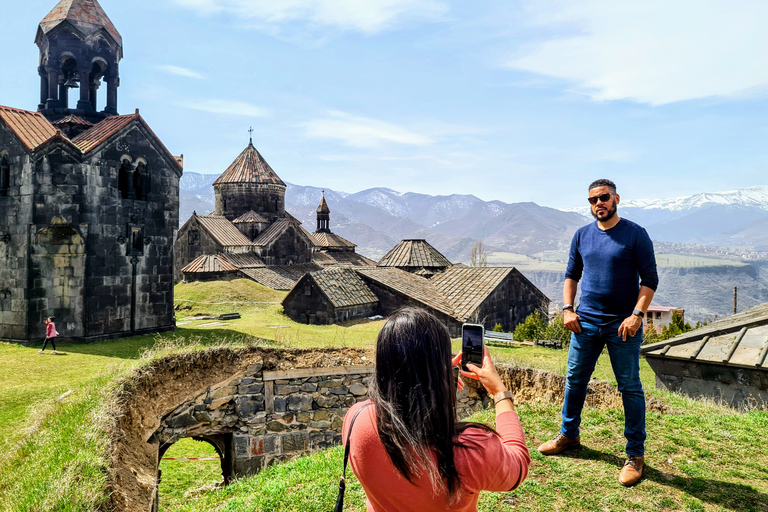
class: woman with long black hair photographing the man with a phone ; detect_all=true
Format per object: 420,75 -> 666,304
342,308 -> 531,512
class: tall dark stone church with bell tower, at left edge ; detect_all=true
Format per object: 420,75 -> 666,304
0,0 -> 182,342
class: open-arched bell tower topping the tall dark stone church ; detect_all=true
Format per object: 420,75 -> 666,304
35,0 -> 123,123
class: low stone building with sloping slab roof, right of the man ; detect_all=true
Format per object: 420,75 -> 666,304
641,303 -> 768,409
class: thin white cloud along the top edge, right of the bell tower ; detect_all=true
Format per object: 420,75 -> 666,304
176,0 -> 448,34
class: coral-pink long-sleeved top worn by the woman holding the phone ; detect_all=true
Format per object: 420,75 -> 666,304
342,402 -> 531,512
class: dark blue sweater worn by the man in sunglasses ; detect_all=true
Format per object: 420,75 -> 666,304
565,219 -> 659,325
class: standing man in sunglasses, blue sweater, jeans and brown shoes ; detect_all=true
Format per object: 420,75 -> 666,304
539,180 -> 659,486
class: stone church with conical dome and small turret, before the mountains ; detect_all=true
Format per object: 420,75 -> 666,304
174,141 -> 376,284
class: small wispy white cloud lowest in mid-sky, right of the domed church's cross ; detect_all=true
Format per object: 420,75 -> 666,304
302,111 -> 433,148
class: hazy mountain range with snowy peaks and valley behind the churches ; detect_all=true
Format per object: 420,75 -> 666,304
180,172 -> 768,321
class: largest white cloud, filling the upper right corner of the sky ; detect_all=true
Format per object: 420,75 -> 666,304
506,0 -> 768,105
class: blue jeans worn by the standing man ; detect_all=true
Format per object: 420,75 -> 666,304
560,320 -> 645,457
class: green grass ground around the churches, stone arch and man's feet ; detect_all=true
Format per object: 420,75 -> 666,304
0,282 -> 768,512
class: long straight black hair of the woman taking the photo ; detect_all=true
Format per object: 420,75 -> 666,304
371,308 -> 492,503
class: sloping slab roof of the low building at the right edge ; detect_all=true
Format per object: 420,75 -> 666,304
641,303 -> 768,370
